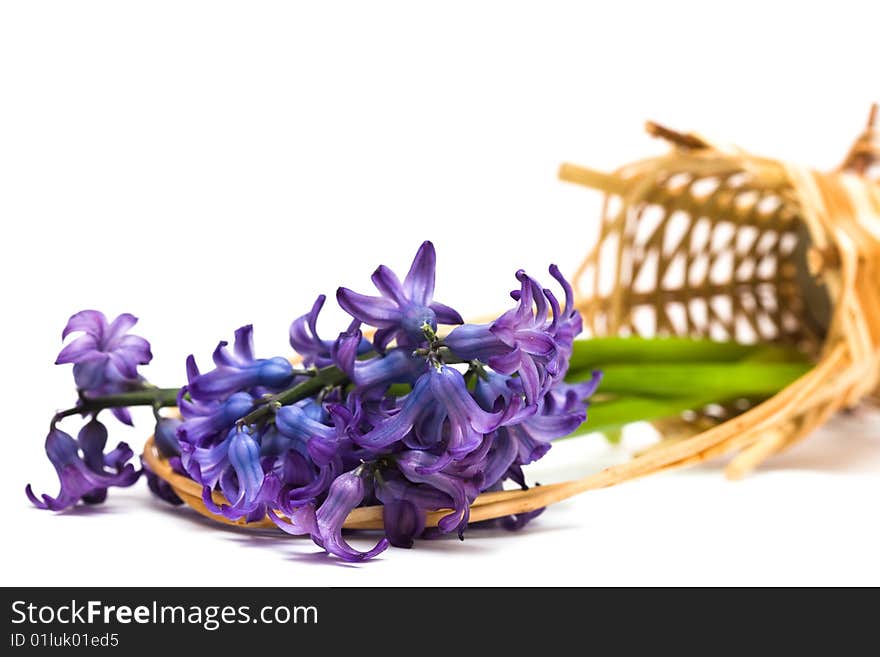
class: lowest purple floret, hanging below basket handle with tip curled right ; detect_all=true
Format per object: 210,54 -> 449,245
313,471 -> 388,562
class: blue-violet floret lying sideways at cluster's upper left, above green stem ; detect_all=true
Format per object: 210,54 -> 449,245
188,325 -> 294,401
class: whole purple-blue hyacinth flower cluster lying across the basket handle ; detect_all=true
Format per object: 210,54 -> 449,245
27,242 -> 600,561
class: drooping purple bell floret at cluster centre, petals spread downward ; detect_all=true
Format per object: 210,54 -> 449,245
352,365 -> 508,467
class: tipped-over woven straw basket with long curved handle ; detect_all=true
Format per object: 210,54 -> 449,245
144,106 -> 880,529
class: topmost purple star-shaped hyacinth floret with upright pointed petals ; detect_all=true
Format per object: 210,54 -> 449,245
336,242 -> 463,351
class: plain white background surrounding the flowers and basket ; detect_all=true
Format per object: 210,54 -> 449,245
0,0 -> 880,585
